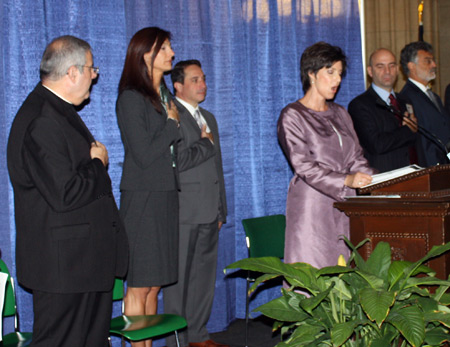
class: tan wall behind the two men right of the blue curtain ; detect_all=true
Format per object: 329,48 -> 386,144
364,0 -> 450,97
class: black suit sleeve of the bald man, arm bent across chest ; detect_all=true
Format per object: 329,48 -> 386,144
348,99 -> 416,154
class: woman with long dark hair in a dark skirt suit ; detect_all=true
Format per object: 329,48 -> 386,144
116,27 -> 179,346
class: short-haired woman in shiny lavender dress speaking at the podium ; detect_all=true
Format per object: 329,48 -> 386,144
278,42 -> 374,268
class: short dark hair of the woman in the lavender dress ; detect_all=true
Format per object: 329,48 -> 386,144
300,41 -> 347,93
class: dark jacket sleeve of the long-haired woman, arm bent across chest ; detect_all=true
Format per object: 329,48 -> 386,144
116,90 -> 180,169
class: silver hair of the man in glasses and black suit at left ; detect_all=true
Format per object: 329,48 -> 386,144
40,35 -> 91,81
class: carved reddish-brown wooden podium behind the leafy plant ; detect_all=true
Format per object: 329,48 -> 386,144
334,164 -> 450,279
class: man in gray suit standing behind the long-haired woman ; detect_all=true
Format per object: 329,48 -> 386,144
164,60 -> 227,347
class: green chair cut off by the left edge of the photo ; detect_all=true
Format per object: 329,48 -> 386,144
0,259 -> 32,347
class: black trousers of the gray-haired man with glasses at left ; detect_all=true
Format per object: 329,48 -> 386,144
31,290 -> 112,347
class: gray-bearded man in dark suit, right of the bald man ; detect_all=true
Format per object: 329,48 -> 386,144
400,41 -> 450,166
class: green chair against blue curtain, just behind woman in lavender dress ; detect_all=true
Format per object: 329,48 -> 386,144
242,214 -> 286,347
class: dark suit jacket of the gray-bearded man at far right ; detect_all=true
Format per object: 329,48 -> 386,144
400,80 -> 450,166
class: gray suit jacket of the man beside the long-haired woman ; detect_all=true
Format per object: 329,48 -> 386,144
175,100 -> 227,224
